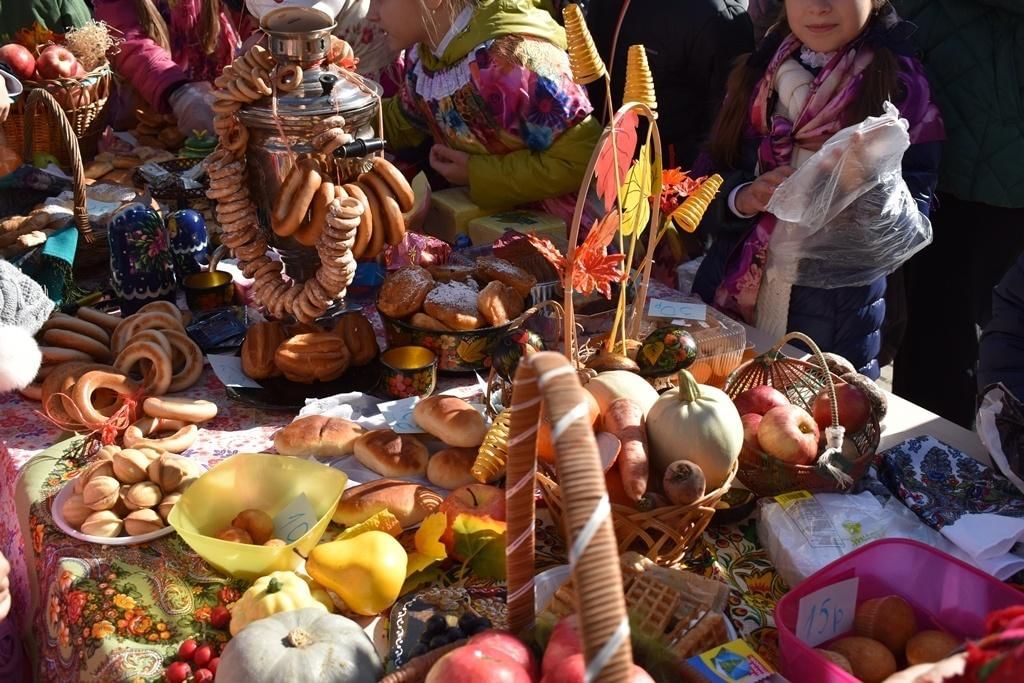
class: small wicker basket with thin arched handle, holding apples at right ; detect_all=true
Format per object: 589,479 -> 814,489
725,332 -> 882,496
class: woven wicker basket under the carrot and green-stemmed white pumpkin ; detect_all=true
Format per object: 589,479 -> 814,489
537,465 -> 736,566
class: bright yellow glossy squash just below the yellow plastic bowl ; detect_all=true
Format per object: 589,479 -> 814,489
306,531 -> 409,616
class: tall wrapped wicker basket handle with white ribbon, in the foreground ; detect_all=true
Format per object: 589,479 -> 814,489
506,351 -> 633,683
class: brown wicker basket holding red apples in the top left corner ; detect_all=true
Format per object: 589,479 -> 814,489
3,65 -> 112,167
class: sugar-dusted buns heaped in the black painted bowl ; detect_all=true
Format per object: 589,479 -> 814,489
377,256 -> 537,332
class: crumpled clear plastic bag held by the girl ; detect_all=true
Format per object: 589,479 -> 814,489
767,102 -> 932,289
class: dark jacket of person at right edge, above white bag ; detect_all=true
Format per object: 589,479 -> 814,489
978,255 -> 1024,399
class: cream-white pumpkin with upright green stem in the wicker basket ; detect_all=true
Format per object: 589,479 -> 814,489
646,370 -> 743,492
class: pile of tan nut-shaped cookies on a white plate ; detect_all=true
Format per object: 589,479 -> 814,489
60,445 -> 201,538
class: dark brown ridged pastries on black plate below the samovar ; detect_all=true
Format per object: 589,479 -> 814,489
242,312 -> 379,384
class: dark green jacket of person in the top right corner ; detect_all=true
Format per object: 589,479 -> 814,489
893,0 -> 1024,208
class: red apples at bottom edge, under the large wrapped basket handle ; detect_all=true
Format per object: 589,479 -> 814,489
426,615 -> 654,683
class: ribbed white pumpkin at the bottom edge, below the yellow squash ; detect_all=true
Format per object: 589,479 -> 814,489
217,607 -> 384,683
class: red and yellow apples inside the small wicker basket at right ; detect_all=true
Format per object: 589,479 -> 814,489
733,383 -> 871,465
